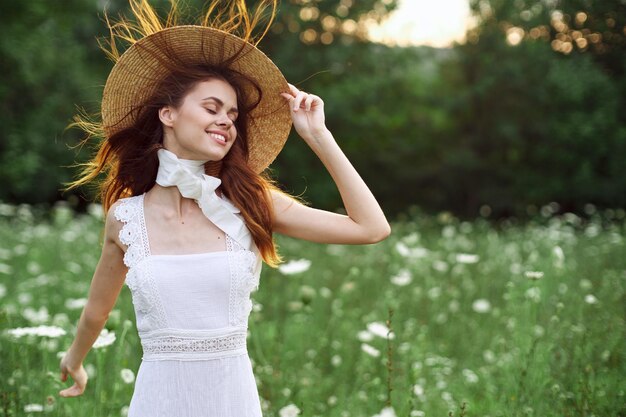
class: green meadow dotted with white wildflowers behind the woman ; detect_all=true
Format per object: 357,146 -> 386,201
0,200 -> 626,417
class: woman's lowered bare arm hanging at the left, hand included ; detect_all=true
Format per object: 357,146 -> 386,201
59,203 -> 128,397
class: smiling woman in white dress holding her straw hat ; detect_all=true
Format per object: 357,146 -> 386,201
60,0 -> 390,417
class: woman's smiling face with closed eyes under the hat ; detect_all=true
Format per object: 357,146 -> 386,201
159,79 -> 238,161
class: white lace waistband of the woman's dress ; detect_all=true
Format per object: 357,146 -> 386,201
139,328 -> 248,361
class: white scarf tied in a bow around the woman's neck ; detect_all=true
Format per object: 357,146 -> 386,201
156,148 -> 258,253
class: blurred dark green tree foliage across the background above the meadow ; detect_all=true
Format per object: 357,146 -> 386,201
0,0 -> 626,219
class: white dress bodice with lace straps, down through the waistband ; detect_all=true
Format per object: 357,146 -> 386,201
114,194 -> 261,360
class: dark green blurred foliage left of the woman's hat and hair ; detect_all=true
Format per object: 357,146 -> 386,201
0,0 -> 112,203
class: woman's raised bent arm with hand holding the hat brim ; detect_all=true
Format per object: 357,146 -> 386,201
272,84 -> 391,244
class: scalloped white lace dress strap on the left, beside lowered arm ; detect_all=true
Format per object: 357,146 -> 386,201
114,194 -> 150,268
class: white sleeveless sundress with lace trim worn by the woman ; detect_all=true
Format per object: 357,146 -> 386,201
114,194 -> 262,417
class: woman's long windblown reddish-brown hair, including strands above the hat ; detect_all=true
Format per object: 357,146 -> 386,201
64,0 -> 303,267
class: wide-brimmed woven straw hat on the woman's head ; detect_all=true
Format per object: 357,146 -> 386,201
102,25 -> 291,173
